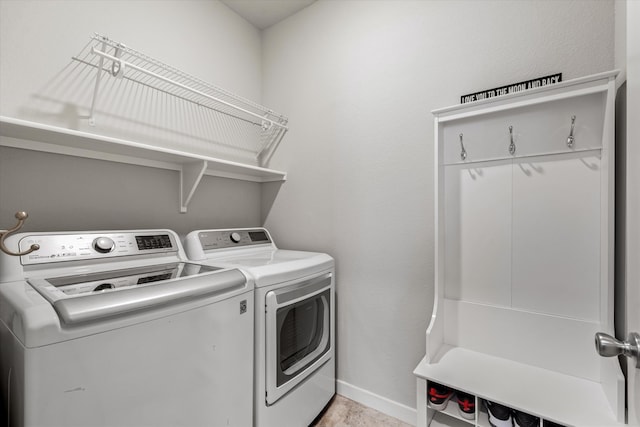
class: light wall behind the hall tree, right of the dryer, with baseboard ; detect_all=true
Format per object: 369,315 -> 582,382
263,0 -> 614,422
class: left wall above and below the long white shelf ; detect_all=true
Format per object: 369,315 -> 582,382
0,0 -> 262,233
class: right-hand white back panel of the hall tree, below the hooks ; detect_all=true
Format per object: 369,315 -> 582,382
512,153 -> 600,321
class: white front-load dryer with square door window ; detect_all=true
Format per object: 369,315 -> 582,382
185,228 -> 335,427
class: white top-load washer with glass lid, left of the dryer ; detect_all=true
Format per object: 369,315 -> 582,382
0,230 -> 254,427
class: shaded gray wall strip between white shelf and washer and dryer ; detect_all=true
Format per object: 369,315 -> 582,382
0,147 -> 261,235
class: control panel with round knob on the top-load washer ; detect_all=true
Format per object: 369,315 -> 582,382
19,230 -> 178,265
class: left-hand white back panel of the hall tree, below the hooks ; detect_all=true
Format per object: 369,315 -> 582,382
444,161 -> 511,306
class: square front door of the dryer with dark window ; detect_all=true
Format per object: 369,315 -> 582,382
265,274 -> 333,405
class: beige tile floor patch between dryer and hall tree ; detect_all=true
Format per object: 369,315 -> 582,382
310,394 -> 410,427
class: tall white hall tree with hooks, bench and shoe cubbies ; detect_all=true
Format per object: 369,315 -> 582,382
414,72 -> 624,427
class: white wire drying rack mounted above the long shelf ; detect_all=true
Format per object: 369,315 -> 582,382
73,34 -> 288,166
